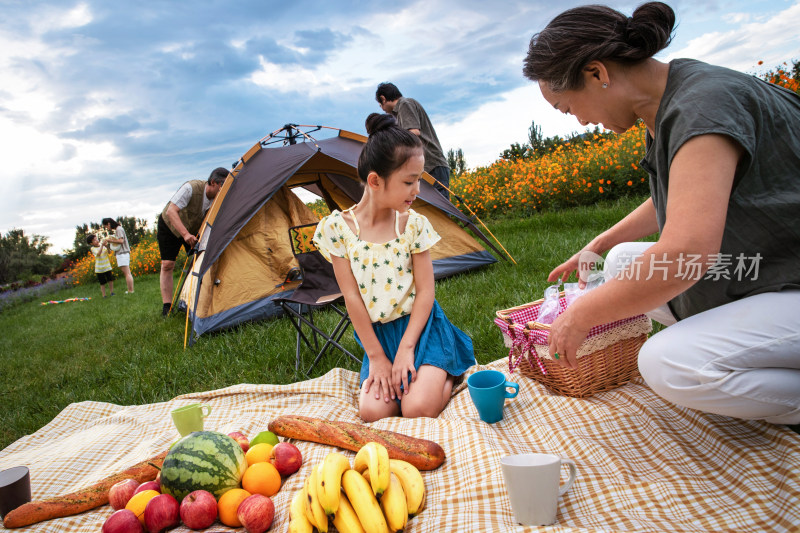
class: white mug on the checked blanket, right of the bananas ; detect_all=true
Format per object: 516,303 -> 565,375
500,453 -> 576,526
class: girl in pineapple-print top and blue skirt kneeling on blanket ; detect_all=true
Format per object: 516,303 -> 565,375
314,113 -> 475,422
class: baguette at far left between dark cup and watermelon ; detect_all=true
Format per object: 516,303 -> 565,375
3,452 -> 167,529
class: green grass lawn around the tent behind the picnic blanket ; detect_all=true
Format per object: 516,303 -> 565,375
0,195 -> 641,448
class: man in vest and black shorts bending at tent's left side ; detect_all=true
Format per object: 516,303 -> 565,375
157,167 -> 228,316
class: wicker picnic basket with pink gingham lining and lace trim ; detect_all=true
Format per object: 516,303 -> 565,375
494,292 -> 653,398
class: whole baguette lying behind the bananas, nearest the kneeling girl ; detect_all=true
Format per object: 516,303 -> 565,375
269,416 -> 445,470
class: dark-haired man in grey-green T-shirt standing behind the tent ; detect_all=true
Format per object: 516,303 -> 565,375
375,83 -> 450,199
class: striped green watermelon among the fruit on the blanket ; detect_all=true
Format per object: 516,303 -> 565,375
161,431 -> 247,502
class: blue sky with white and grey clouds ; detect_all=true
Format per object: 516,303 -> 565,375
0,0 -> 800,253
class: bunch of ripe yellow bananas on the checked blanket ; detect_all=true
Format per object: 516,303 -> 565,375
289,442 -> 425,533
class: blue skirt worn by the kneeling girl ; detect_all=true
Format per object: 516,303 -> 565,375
353,300 -> 476,383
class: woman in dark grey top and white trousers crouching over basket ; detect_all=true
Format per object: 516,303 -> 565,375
524,2 -> 800,424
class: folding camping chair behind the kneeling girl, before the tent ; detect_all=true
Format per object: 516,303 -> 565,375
278,224 -> 361,376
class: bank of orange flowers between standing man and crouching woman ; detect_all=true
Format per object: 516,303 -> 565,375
451,124 -> 649,214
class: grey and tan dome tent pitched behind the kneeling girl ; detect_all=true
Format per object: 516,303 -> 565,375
178,124 -> 500,343
